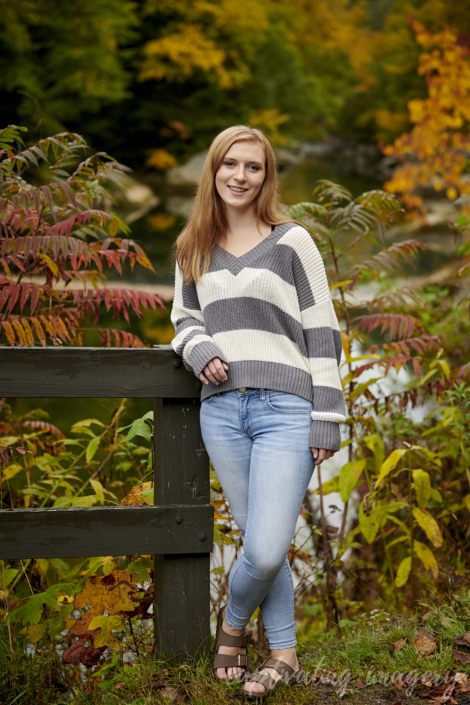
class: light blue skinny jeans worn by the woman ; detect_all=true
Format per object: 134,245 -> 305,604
201,388 -> 313,649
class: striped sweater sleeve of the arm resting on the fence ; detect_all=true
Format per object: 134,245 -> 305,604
171,264 -> 224,377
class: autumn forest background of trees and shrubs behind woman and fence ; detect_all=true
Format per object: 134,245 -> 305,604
0,0 -> 470,703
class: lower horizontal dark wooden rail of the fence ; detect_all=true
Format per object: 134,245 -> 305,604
0,504 -> 214,560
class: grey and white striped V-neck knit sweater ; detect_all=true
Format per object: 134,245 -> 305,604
171,223 -> 346,450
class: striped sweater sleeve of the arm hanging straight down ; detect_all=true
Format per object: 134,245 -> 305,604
292,227 -> 347,450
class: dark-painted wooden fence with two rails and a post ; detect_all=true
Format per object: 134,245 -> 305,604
0,345 -> 214,656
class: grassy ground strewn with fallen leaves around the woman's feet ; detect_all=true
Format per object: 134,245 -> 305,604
0,596 -> 470,705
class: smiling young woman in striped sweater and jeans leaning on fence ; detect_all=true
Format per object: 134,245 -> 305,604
171,125 -> 346,698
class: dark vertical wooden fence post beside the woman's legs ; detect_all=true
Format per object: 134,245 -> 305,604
154,399 -> 213,658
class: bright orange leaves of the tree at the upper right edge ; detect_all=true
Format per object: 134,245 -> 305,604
384,20 -> 470,214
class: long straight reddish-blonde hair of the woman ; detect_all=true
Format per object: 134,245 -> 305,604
173,125 -> 291,284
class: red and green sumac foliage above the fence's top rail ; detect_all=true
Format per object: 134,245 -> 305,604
0,127 -> 163,347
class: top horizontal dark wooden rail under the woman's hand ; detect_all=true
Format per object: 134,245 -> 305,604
0,345 -> 201,399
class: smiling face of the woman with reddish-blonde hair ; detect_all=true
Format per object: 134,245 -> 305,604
215,140 -> 266,210
